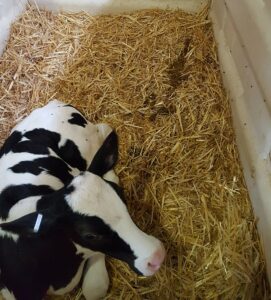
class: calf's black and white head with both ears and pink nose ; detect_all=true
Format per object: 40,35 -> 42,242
1,132 -> 165,276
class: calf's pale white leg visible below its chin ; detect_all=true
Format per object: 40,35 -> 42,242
82,253 -> 109,300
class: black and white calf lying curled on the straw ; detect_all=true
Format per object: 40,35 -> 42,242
0,100 -> 165,300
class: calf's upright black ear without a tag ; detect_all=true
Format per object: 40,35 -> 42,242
88,131 -> 118,176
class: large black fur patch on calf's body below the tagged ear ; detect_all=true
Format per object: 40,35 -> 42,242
0,231 -> 83,300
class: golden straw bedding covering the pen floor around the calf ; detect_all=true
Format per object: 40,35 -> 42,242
0,2 -> 269,300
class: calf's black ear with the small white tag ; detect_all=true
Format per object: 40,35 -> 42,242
0,210 -> 57,236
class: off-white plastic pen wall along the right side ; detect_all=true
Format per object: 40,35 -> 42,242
211,0 -> 271,279
